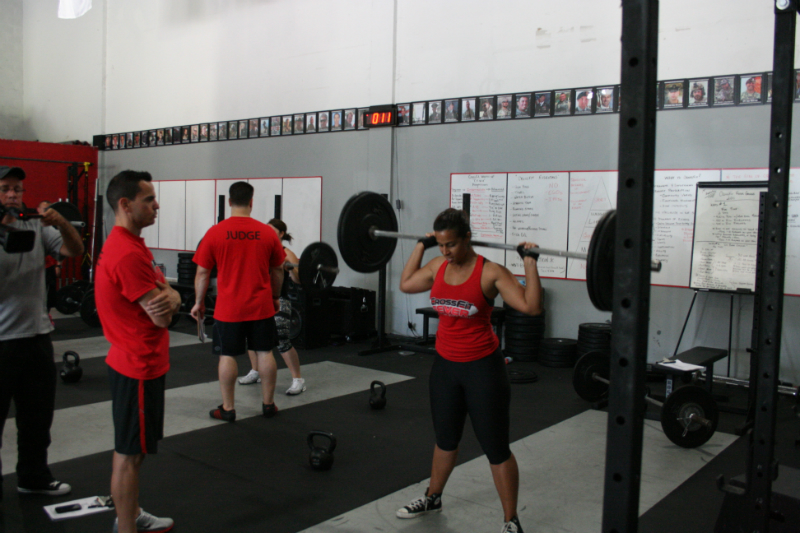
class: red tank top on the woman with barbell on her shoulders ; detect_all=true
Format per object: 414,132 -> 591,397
431,255 -> 500,363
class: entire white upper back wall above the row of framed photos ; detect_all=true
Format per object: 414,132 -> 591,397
15,0 -> 800,141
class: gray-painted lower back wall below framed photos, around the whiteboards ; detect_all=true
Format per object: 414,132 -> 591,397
101,106 -> 800,382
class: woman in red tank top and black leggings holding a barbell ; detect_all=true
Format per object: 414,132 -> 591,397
397,209 -> 542,533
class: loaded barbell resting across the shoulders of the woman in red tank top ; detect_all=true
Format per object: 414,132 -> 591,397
337,191 -> 661,311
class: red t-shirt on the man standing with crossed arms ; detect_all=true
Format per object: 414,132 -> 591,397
94,226 -> 169,379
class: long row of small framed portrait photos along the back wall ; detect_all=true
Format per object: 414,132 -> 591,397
101,70 -> 800,150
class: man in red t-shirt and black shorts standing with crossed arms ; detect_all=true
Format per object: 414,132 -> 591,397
95,170 -> 181,533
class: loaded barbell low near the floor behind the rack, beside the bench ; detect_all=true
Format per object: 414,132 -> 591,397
572,352 -> 719,448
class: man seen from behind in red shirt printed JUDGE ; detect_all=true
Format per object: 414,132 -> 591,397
192,181 -> 286,422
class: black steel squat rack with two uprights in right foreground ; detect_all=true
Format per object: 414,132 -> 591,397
602,0 -> 800,533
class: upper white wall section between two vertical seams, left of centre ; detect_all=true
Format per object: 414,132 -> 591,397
101,0 -> 393,132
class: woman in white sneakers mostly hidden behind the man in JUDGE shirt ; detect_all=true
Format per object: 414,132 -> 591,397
239,218 -> 306,396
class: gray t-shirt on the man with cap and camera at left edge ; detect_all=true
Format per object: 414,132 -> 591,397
0,219 -> 63,341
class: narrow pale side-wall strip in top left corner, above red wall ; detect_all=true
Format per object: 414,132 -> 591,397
0,0 -> 23,139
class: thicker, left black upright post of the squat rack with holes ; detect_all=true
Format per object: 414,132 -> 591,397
602,0 -> 659,533
